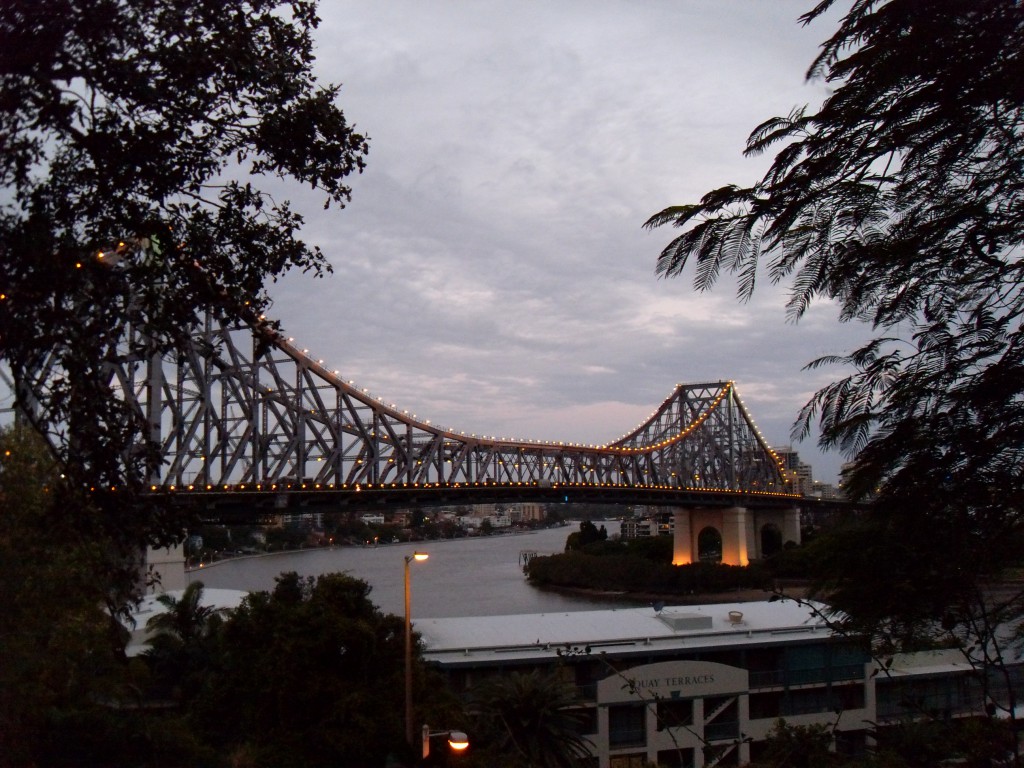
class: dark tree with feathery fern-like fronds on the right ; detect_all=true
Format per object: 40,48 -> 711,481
646,0 -> 1024,643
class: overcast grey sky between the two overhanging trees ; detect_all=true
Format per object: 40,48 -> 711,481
271,0 -> 864,481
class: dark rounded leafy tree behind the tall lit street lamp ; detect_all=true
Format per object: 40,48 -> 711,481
189,572 -> 458,766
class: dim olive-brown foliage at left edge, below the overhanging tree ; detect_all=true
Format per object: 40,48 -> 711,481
0,428 -> 136,766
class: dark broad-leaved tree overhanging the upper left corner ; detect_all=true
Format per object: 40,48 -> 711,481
0,0 -> 368,577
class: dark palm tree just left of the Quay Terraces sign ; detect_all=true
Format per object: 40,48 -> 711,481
474,671 -> 590,768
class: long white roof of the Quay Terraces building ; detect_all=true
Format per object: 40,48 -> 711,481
415,600 -> 830,665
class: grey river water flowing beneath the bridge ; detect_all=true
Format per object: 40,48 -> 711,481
180,520 -> 638,618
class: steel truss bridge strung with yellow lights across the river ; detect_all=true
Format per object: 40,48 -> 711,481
9,318 -> 798,514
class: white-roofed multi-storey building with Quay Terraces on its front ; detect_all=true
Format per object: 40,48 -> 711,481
416,601 -> 1007,768
